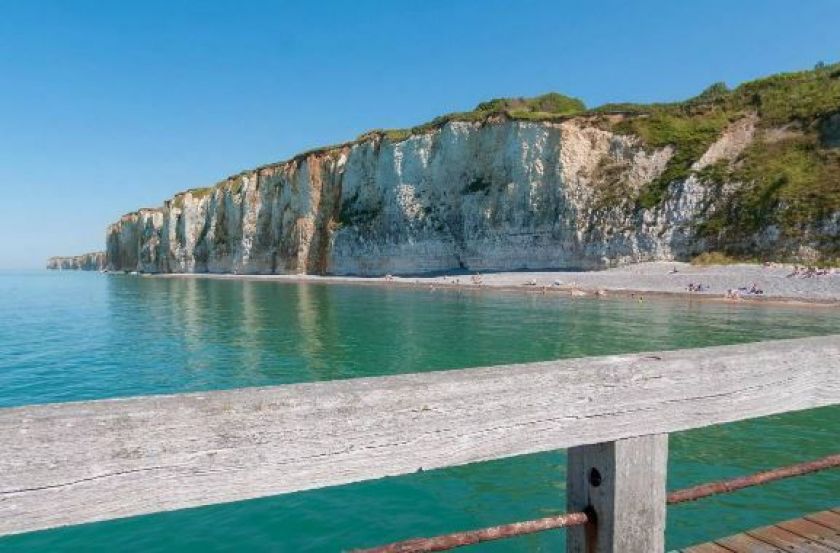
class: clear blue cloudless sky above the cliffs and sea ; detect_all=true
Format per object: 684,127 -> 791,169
0,0 -> 840,268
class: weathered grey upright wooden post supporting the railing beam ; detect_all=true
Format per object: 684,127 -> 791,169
566,434 -> 668,553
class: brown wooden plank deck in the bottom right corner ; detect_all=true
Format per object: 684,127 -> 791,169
683,508 -> 840,553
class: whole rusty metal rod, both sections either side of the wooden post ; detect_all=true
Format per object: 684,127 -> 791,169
353,454 -> 840,553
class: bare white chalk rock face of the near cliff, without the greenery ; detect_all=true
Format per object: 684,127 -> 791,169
107,119 -> 751,275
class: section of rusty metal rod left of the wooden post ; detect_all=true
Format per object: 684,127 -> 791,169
353,513 -> 589,553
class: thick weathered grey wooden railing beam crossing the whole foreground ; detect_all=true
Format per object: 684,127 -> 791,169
0,336 -> 840,534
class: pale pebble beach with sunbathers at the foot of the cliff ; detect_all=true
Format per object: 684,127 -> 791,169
140,262 -> 840,307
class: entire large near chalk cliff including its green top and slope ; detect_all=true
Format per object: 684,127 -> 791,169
106,64 -> 840,275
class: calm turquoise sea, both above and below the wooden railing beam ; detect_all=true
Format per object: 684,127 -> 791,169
0,272 -> 840,552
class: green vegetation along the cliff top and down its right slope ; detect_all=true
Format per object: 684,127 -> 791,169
153,64 -> 840,260
